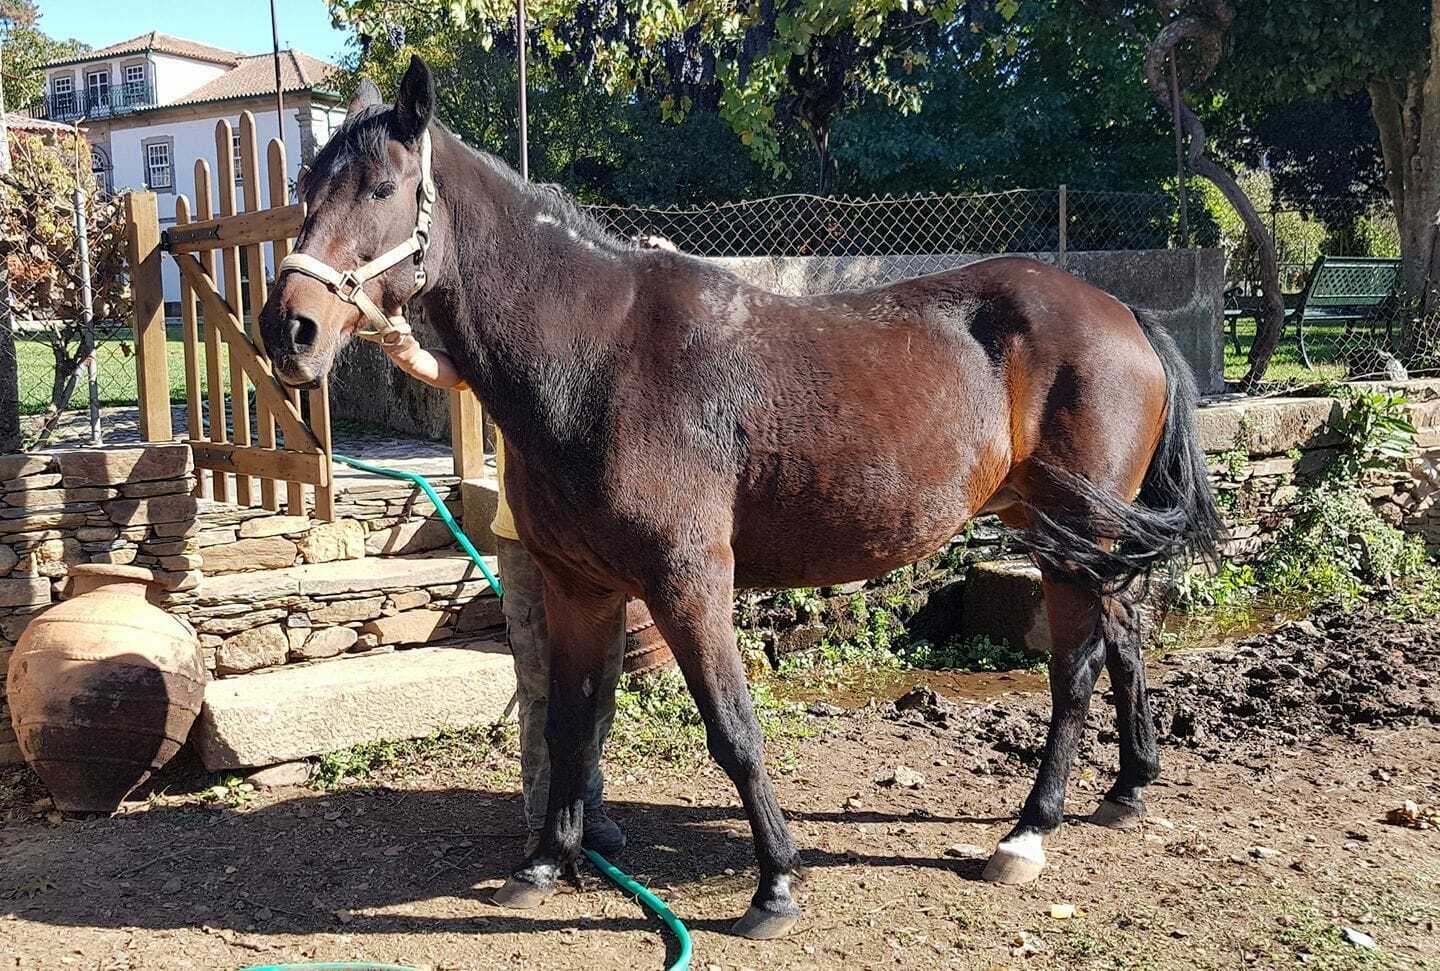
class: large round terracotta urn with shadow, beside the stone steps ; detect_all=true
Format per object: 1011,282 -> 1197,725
6,563 -> 206,813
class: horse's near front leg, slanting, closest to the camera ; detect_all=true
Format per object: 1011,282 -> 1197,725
645,547 -> 801,941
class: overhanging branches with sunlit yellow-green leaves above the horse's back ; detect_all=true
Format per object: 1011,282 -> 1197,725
330,0 -> 1020,192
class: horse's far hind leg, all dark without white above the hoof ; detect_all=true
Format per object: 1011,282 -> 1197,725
1090,594 -> 1161,830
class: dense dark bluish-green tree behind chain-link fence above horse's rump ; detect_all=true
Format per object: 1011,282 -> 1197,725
835,0 -> 1175,194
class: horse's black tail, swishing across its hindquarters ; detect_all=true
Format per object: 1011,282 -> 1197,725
1021,308 -> 1223,592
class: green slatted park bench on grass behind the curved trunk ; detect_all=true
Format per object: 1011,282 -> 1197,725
1225,256 -> 1400,367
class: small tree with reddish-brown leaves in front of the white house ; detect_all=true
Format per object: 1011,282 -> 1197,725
0,133 -> 130,441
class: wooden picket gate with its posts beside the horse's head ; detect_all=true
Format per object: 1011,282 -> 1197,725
127,111 -> 484,520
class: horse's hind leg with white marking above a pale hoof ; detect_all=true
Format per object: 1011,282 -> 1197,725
984,570 -> 1104,883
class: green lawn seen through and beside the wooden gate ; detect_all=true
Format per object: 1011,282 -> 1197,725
16,323 -> 230,415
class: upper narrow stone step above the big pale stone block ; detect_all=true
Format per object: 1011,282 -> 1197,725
173,553 -> 497,605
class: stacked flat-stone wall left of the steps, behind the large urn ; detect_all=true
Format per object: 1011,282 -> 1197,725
0,445 -> 200,765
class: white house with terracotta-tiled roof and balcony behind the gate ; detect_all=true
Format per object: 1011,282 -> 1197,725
33,32 -> 346,301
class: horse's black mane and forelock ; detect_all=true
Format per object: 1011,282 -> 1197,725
310,105 -> 635,251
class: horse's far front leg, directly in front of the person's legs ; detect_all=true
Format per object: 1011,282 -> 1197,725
494,575 -> 625,909
